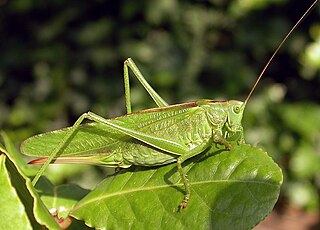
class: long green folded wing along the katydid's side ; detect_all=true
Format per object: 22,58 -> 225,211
21,103 -> 212,165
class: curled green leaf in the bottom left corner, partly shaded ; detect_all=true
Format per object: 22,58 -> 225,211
0,134 -> 59,229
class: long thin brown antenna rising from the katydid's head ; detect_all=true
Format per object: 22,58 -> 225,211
244,0 -> 318,105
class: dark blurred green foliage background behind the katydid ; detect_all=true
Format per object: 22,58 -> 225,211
0,0 -> 320,210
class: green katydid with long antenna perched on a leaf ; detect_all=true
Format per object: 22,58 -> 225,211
21,0 -> 318,208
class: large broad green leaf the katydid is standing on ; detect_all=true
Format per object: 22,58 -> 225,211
71,145 -> 283,229
